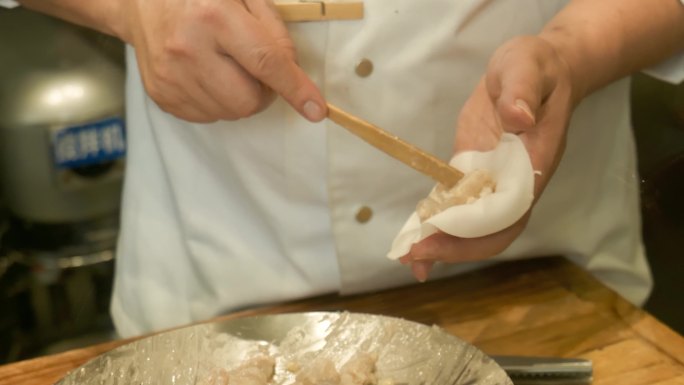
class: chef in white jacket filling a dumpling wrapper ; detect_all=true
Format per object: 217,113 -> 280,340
5,0 -> 684,336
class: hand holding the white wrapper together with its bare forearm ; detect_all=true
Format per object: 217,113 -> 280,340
402,0 -> 684,280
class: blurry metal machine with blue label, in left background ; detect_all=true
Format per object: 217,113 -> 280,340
0,8 -> 126,360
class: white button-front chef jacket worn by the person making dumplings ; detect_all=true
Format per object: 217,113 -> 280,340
112,0 -> 680,336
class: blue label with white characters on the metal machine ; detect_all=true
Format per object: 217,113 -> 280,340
52,118 -> 126,168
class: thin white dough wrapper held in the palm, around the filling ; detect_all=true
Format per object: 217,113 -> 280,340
387,133 -> 535,259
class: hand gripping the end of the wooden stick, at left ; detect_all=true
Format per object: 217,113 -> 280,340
119,0 -> 325,122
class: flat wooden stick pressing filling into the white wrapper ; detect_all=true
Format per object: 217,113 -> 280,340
328,104 -> 463,188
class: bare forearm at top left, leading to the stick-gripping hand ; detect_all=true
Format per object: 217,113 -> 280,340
19,0 -> 123,37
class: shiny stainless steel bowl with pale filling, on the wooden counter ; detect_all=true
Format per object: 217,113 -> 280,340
57,312 -> 512,385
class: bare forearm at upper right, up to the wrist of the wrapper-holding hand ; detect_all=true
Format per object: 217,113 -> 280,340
540,0 -> 684,101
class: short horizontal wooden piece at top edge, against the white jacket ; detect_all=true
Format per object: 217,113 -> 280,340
275,1 -> 363,22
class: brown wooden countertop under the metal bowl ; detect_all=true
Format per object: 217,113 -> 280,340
0,258 -> 684,385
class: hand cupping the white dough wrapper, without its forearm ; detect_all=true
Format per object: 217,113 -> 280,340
401,36 -> 575,281
